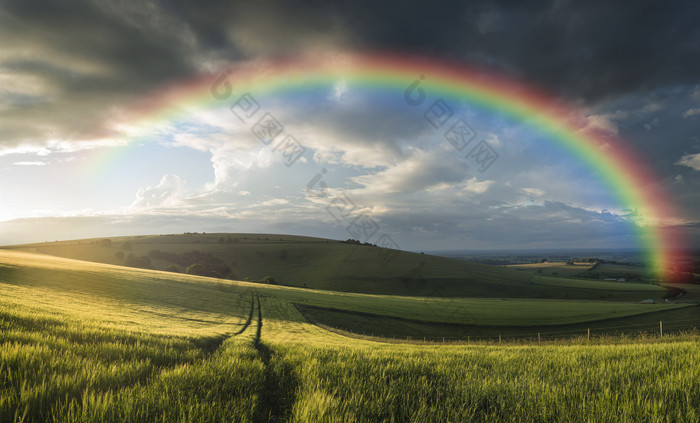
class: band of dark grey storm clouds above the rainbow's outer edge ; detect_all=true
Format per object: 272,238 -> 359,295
0,0 -> 700,149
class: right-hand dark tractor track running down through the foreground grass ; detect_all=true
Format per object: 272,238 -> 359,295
253,297 -> 299,423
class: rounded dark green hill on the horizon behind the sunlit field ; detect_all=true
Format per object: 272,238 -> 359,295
6,234 -> 680,302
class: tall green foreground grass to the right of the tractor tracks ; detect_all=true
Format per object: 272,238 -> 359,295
279,342 -> 700,422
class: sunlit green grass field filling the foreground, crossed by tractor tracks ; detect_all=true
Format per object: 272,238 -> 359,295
0,250 -> 700,422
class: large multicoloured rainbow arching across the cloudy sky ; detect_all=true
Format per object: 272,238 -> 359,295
101,53 -> 683,280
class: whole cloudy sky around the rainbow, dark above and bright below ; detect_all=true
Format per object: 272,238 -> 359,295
0,0 -> 700,250
